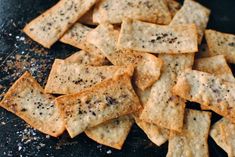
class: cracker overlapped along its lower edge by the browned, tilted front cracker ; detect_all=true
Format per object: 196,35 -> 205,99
45,59 -> 134,94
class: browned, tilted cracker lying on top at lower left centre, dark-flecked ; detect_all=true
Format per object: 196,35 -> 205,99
56,74 -> 141,138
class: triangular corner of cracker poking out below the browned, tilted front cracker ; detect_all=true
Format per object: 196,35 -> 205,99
85,115 -> 134,150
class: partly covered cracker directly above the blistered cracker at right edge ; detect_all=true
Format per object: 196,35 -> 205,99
194,55 -> 235,83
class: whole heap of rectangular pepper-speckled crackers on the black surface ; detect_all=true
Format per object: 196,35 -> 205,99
1,0 -> 235,157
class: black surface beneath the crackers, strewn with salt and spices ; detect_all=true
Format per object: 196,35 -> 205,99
0,0 -> 235,157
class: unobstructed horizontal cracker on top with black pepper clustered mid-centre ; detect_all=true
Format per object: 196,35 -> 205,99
117,19 -> 198,54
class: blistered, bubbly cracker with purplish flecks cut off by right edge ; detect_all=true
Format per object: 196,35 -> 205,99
172,70 -> 235,122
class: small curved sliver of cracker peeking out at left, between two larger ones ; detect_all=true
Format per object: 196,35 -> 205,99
64,50 -> 108,66
